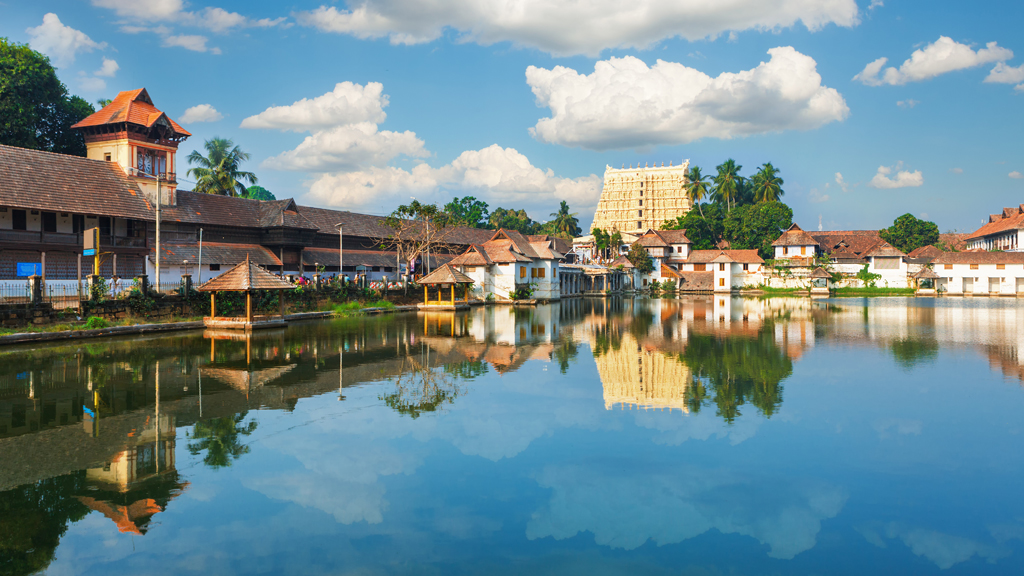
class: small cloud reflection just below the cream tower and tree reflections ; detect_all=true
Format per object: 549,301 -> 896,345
636,410 -> 764,446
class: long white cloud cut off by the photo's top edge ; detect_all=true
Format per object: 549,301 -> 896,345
294,0 -> 859,56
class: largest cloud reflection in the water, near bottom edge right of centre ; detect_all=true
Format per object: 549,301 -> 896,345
526,462 -> 847,559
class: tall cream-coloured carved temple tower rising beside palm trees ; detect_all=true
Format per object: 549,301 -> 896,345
593,160 -> 691,234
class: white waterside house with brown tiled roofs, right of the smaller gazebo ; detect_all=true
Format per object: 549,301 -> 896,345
451,230 -> 563,300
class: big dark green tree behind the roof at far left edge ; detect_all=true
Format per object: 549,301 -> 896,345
0,38 -> 95,156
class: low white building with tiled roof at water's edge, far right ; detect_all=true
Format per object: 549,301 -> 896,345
932,252 -> 1024,295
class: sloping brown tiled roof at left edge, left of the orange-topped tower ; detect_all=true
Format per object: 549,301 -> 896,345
0,145 -> 153,220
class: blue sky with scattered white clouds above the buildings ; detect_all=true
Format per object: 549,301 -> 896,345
0,0 -> 1024,232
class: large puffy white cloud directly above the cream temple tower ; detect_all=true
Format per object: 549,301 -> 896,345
526,46 -> 850,150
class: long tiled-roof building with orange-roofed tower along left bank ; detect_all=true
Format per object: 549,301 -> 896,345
0,89 -> 494,282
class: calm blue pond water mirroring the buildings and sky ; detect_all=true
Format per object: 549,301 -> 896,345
0,297 -> 1024,575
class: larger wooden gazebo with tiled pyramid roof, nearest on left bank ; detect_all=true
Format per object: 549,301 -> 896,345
197,254 -> 295,331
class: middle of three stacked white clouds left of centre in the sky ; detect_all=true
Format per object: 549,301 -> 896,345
262,122 -> 430,172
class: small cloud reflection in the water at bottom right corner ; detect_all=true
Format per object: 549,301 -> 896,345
856,522 -> 1020,570
